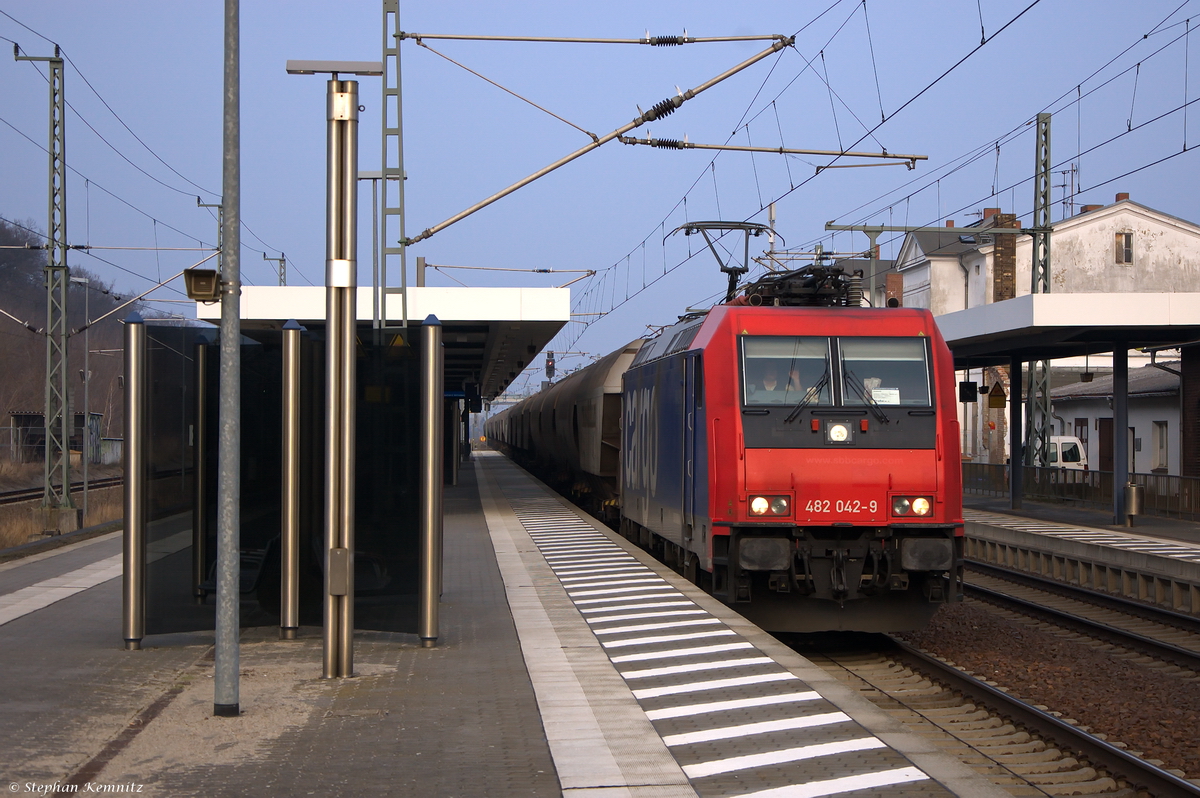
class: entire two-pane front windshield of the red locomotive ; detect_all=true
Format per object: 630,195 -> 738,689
742,336 -> 931,407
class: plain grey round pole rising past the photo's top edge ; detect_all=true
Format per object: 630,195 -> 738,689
212,0 -> 241,716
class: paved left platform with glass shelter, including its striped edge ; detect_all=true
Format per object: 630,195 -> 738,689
0,452 -> 1007,798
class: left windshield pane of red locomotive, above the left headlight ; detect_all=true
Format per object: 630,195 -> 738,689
742,336 -> 833,404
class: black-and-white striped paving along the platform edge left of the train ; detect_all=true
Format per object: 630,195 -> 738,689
506,488 -> 949,797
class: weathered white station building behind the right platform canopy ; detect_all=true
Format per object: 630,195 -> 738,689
894,193 -> 1200,474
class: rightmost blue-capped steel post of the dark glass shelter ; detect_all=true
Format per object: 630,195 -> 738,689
418,314 -> 444,648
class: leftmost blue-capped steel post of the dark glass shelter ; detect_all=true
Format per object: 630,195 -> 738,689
121,313 -> 146,652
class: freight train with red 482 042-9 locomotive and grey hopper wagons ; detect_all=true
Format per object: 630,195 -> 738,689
485,265 -> 962,632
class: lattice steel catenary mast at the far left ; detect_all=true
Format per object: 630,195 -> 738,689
13,44 -> 74,525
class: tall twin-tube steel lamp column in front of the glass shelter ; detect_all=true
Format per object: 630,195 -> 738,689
323,73 -> 359,679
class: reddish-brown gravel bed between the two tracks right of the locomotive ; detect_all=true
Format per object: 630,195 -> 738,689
902,602 -> 1200,778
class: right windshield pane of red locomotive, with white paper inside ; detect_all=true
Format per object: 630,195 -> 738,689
839,337 -> 930,407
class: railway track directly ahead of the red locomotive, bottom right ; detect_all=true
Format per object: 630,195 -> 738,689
805,638 -> 1200,798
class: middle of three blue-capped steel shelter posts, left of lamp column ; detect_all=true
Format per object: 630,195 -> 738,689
280,319 -> 304,640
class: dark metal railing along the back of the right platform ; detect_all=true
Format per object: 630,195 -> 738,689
962,463 -> 1200,521
